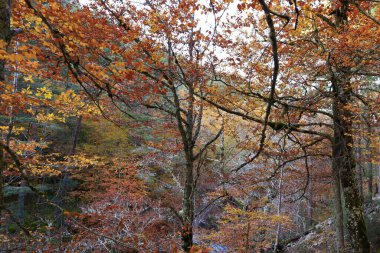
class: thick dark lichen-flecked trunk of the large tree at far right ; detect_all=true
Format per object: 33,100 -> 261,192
329,0 -> 370,253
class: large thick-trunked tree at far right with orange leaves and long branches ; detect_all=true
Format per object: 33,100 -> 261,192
200,1 -> 378,252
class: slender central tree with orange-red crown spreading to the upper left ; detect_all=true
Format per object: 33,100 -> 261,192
17,1 -> 229,251
